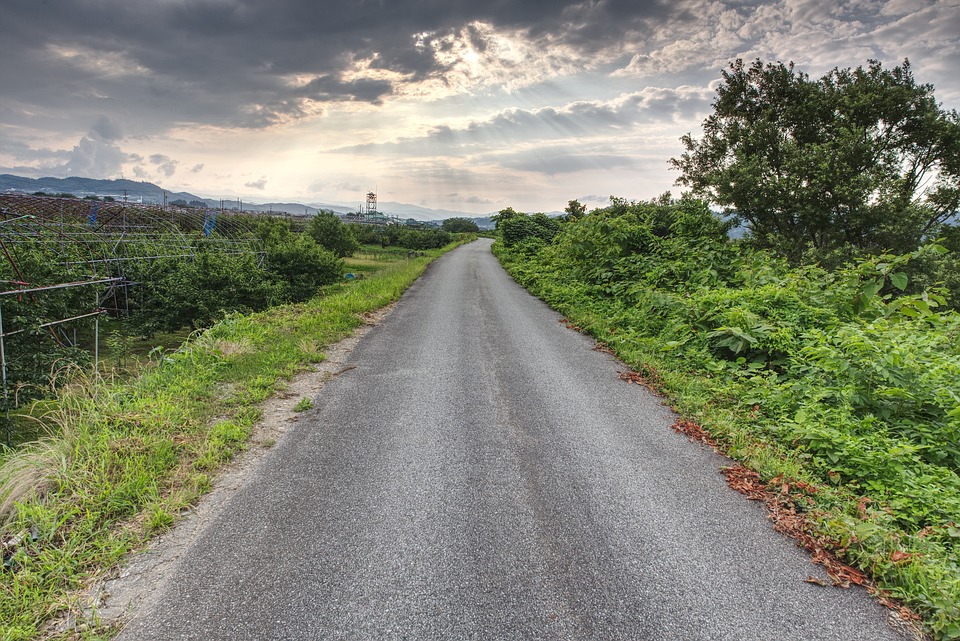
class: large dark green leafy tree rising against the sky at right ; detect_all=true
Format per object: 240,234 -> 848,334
671,60 -> 960,261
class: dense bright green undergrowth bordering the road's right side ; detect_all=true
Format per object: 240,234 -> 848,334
494,196 -> 960,639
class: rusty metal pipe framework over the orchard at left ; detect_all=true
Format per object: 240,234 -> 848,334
0,193 -> 264,444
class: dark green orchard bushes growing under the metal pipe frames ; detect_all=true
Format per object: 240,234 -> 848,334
0,217 -> 344,407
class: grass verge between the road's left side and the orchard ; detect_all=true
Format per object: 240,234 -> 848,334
0,239 -> 466,641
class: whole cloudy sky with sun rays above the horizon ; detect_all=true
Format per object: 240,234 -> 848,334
0,0 -> 960,214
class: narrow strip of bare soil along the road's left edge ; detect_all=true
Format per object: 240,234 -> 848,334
79,305 -> 393,629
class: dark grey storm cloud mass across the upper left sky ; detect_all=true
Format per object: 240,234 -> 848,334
0,0 -> 664,135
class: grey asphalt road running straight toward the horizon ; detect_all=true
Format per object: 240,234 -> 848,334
120,241 -> 900,641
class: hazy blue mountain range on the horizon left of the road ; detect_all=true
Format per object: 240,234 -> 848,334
0,174 -> 493,229
